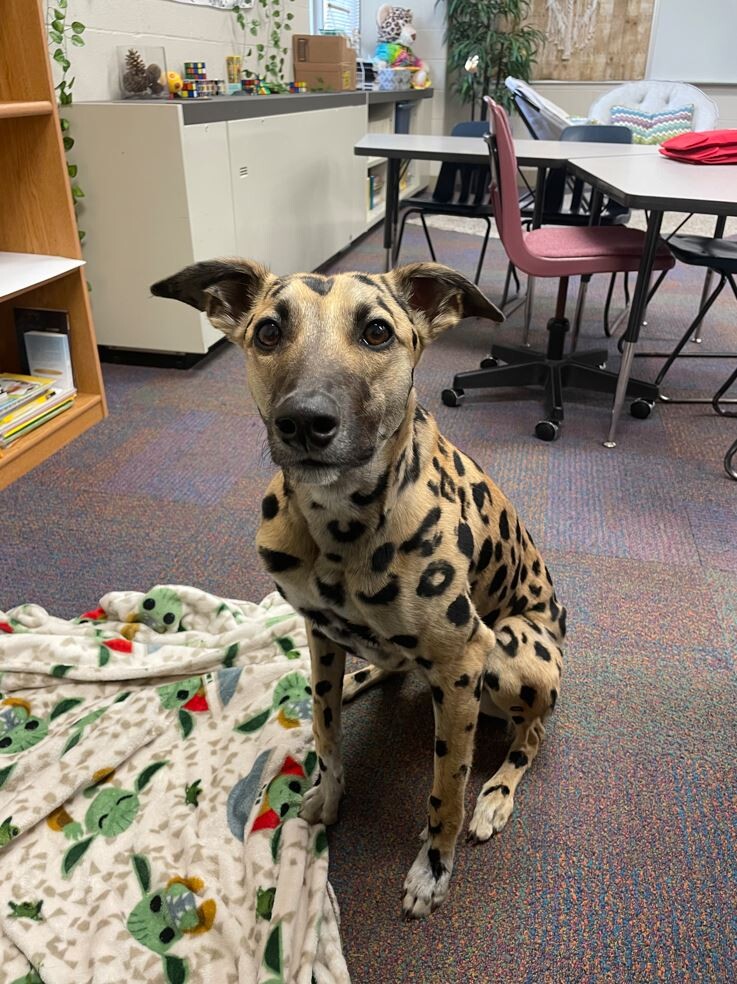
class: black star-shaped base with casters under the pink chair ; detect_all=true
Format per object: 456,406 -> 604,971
442,318 -> 658,441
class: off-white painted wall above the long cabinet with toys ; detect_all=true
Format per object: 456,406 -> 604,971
59,0 -> 310,101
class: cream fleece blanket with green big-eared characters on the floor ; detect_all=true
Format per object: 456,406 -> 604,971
0,586 -> 348,984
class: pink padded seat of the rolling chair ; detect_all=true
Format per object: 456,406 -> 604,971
525,226 -> 675,277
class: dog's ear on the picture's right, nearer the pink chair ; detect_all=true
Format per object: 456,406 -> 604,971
389,263 -> 504,344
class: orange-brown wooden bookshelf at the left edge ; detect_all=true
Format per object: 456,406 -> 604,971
0,0 -> 107,489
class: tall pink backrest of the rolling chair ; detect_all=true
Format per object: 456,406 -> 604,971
484,96 -> 530,273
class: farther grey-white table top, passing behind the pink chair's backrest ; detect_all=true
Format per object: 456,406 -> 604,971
354,133 -> 658,167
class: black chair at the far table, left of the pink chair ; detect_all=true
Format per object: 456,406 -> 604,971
396,120 -> 494,284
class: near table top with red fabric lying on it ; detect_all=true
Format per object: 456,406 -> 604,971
569,154 -> 737,215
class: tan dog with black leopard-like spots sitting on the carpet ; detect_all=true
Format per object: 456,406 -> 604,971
151,260 -> 566,918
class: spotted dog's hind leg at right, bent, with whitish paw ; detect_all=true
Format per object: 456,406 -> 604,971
468,616 -> 561,842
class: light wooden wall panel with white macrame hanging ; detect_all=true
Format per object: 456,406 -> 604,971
530,0 -> 655,82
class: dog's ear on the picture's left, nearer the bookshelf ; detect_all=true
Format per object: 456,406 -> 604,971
151,260 -> 276,341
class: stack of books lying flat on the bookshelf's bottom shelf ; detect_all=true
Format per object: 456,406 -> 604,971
0,372 -> 77,453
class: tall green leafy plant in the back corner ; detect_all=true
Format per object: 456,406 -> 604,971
445,0 -> 545,116
